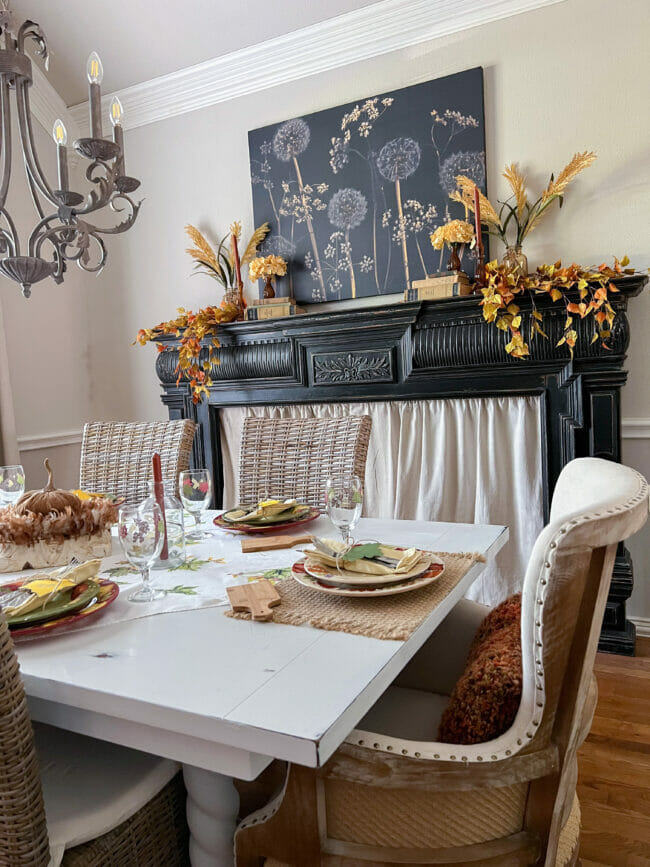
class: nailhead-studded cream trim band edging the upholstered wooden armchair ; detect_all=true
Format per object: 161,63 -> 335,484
346,473 -> 648,762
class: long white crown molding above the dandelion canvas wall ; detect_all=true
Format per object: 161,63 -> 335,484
70,0 -> 565,129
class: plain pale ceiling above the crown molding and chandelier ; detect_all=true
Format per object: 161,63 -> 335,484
11,0 -> 375,105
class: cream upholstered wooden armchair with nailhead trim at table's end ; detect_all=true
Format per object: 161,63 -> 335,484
235,458 -> 648,867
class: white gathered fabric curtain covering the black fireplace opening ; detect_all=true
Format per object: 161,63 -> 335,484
220,397 -> 543,606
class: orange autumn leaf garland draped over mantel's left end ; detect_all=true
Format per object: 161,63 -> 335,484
136,302 -> 239,403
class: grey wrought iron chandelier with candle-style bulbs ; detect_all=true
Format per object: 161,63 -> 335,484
0,0 -> 141,298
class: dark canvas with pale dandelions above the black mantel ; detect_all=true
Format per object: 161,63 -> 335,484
248,68 -> 486,304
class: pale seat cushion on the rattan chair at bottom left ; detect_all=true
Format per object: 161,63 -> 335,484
34,723 -> 179,867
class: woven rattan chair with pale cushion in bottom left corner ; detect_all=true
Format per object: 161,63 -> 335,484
0,612 -> 189,867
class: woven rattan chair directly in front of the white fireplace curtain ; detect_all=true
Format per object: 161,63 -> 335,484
239,415 -> 372,511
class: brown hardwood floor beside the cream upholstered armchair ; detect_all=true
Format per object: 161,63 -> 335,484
578,638 -> 650,867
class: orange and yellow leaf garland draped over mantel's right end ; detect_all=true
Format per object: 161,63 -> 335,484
480,256 -> 635,358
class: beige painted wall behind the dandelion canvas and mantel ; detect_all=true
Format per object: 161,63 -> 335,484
2,0 -> 650,617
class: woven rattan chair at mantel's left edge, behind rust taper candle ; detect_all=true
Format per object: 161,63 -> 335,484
79,419 -> 196,505
